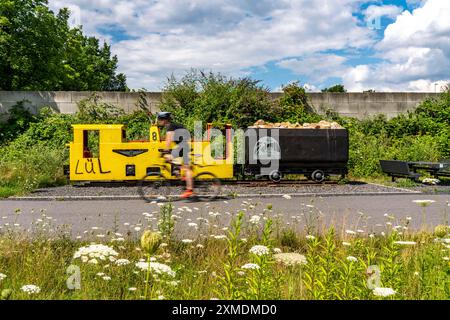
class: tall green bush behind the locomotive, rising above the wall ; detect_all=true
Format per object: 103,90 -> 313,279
160,70 -> 276,130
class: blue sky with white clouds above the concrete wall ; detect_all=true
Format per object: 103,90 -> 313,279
50,0 -> 450,91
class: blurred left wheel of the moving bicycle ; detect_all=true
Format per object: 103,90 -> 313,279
138,176 -> 172,203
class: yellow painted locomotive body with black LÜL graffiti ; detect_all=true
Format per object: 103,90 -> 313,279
68,125 -> 234,181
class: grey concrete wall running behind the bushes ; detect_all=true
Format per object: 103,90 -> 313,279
0,91 -> 436,119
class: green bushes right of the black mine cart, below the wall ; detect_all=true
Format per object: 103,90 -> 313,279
337,87 -> 450,177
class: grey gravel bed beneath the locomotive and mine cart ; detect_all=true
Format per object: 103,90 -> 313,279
23,183 -> 413,197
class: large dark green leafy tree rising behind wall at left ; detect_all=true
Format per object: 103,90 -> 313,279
0,0 -> 127,91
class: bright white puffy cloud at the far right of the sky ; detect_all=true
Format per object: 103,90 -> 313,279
343,0 -> 450,92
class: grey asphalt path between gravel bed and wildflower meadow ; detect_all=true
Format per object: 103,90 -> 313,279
0,194 -> 450,238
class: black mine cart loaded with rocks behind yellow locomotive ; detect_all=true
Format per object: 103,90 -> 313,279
245,128 -> 349,182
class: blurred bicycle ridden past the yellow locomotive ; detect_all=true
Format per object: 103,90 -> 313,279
138,155 -> 222,203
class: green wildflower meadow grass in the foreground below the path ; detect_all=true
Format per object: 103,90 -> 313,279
0,206 -> 450,300
